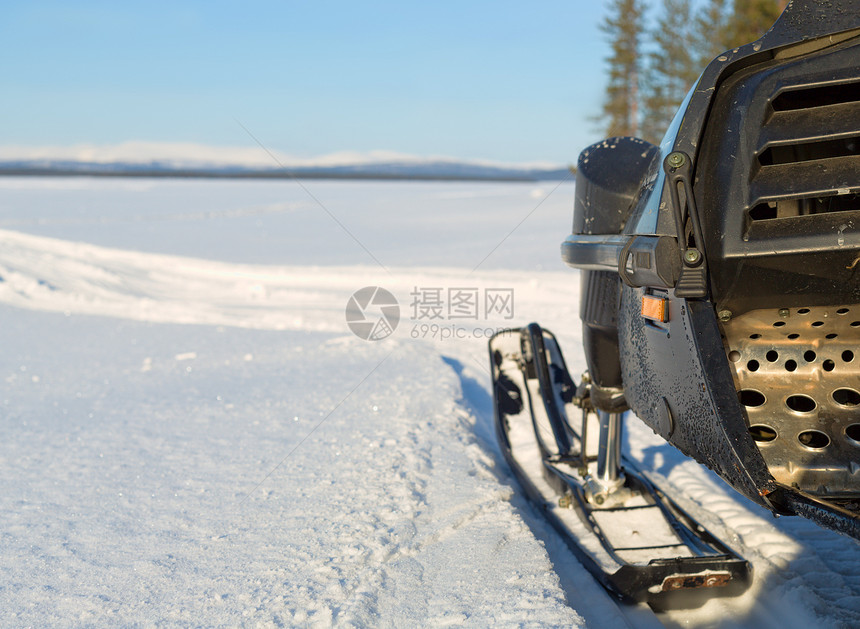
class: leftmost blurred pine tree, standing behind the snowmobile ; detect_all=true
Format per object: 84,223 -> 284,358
600,0 -> 645,136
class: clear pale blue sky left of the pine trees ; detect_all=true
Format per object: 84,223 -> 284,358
0,0 -> 608,163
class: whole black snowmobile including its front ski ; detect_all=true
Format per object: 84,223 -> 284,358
489,0 -> 860,606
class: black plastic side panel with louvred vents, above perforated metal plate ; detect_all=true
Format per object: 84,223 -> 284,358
696,36 -> 860,315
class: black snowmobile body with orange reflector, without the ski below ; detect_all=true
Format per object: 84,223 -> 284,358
562,0 -> 860,539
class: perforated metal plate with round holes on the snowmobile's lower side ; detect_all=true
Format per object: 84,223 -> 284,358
722,304 -> 860,495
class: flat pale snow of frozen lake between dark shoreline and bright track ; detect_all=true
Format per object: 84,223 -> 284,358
0,178 -> 573,271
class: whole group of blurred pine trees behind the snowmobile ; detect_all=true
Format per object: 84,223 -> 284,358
599,0 -> 786,143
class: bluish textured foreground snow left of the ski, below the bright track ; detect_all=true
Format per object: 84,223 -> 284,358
0,306 -> 582,627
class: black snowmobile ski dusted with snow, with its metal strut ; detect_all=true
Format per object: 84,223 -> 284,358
489,323 -> 752,608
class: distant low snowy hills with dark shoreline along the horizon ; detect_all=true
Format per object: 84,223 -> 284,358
0,149 -> 570,181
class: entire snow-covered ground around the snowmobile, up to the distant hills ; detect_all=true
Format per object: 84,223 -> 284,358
0,178 -> 860,629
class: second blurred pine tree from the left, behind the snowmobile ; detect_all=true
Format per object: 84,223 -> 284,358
642,0 -> 701,142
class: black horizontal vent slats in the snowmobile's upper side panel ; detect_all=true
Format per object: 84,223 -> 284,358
747,80 -> 860,228
